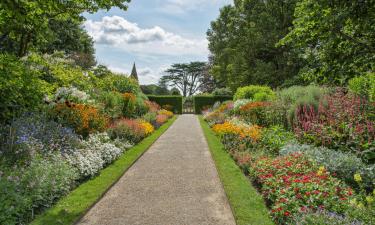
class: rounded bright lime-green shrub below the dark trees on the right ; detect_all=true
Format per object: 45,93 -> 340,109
234,85 -> 276,101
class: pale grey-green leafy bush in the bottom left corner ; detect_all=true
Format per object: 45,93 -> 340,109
0,155 -> 78,224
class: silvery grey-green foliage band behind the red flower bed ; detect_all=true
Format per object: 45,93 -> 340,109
280,144 -> 375,189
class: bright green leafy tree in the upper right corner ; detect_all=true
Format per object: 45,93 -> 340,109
279,0 -> 375,85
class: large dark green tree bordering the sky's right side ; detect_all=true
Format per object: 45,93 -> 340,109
207,0 -> 300,91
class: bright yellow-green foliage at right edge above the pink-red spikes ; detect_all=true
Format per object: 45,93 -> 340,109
349,73 -> 375,102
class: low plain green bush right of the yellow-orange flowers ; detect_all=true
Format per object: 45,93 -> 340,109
259,126 -> 295,155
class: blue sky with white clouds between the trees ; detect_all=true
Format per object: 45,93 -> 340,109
84,0 -> 232,84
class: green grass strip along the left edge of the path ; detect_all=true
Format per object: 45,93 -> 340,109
31,116 -> 177,225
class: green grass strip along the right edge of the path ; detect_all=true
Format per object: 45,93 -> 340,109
199,116 -> 274,225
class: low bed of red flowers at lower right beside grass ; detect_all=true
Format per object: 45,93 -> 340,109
250,154 -> 353,224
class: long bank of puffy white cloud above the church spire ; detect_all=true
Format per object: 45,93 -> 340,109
84,16 -> 208,55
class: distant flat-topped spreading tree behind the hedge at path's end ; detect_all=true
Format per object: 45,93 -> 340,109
160,62 -> 207,97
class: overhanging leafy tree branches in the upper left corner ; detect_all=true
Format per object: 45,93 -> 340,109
0,0 -> 130,57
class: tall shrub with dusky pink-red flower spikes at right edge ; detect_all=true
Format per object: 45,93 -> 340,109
294,92 -> 375,161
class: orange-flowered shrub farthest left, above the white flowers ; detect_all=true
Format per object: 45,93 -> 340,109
52,102 -> 108,137
